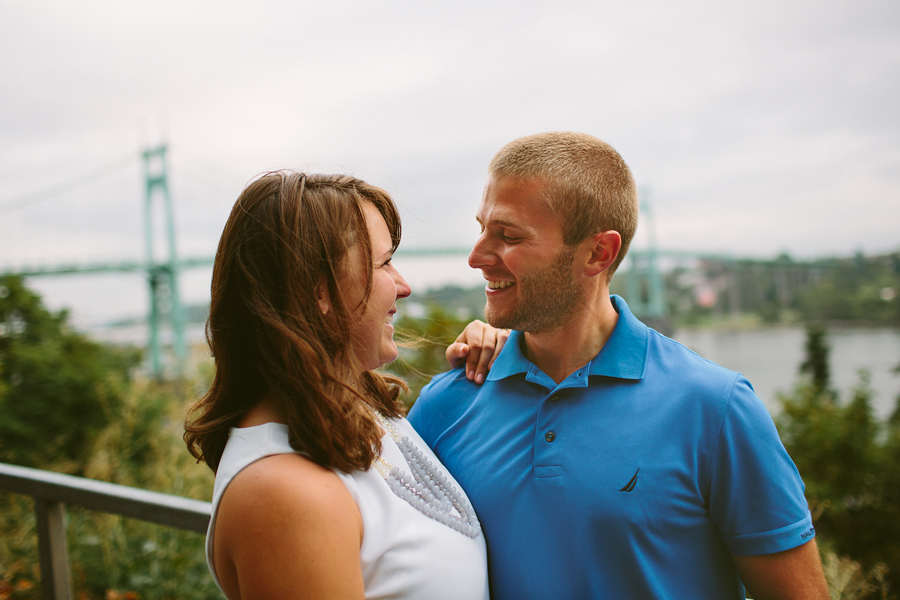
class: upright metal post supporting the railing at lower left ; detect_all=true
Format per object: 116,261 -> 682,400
34,498 -> 72,600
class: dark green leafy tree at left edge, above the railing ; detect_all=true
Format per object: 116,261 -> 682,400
0,276 -> 140,473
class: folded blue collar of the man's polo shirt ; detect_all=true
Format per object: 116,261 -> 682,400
487,295 -> 649,381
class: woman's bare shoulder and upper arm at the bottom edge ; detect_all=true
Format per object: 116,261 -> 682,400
213,454 -> 365,600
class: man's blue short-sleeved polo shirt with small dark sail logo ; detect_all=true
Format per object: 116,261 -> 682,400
409,296 -> 814,600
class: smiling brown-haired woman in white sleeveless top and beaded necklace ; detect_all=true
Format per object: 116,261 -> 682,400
185,172 -> 494,600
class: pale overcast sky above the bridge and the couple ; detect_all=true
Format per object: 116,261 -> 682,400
0,0 -> 900,324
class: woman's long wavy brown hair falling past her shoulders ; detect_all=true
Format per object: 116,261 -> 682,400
184,171 -> 404,472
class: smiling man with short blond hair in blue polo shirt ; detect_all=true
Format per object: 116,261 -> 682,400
409,133 -> 828,600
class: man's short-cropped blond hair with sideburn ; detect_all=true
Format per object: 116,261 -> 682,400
489,131 -> 638,279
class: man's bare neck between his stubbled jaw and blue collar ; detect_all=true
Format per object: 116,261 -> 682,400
522,293 -> 619,383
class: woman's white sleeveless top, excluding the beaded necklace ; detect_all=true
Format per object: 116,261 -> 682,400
206,419 -> 488,600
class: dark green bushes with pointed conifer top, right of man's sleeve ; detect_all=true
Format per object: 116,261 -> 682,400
776,328 -> 900,597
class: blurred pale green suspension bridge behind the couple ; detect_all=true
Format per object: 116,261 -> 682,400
0,144 -> 704,377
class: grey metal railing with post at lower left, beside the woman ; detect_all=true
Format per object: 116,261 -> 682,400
0,463 -> 212,600
